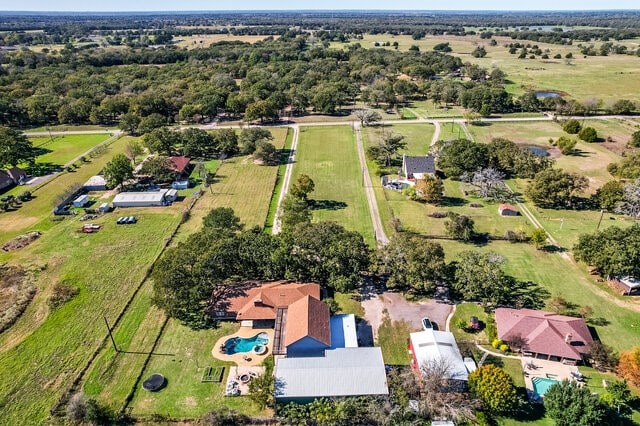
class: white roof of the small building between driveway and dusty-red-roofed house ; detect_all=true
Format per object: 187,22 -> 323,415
409,329 -> 469,380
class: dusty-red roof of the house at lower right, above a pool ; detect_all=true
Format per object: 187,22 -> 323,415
495,308 -> 593,360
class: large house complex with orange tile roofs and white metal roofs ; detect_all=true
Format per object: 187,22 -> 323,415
215,282 -> 389,402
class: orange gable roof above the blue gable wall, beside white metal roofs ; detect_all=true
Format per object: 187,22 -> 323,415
284,295 -> 331,346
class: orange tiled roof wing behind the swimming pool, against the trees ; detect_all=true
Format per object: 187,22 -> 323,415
226,281 -> 320,321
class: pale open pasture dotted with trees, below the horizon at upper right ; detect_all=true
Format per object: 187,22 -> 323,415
332,34 -> 640,103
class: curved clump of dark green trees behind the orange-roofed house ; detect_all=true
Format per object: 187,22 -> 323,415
153,208 -> 370,327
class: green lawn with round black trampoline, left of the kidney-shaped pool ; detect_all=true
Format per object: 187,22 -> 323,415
130,320 -> 268,419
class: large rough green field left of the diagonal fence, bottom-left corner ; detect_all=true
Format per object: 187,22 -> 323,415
0,208 -> 180,424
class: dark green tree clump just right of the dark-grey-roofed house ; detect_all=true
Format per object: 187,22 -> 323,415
434,138 -> 553,179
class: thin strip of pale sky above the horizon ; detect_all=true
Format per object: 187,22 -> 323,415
0,0 -> 640,12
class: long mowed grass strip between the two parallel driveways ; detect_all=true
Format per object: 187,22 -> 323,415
292,126 -> 373,244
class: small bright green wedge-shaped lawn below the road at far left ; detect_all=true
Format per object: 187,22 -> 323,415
29,134 -> 110,166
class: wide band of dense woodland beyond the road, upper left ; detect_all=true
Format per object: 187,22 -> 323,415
0,37 -> 462,127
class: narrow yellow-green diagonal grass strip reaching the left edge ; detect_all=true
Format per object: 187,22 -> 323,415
0,136 -> 133,242
